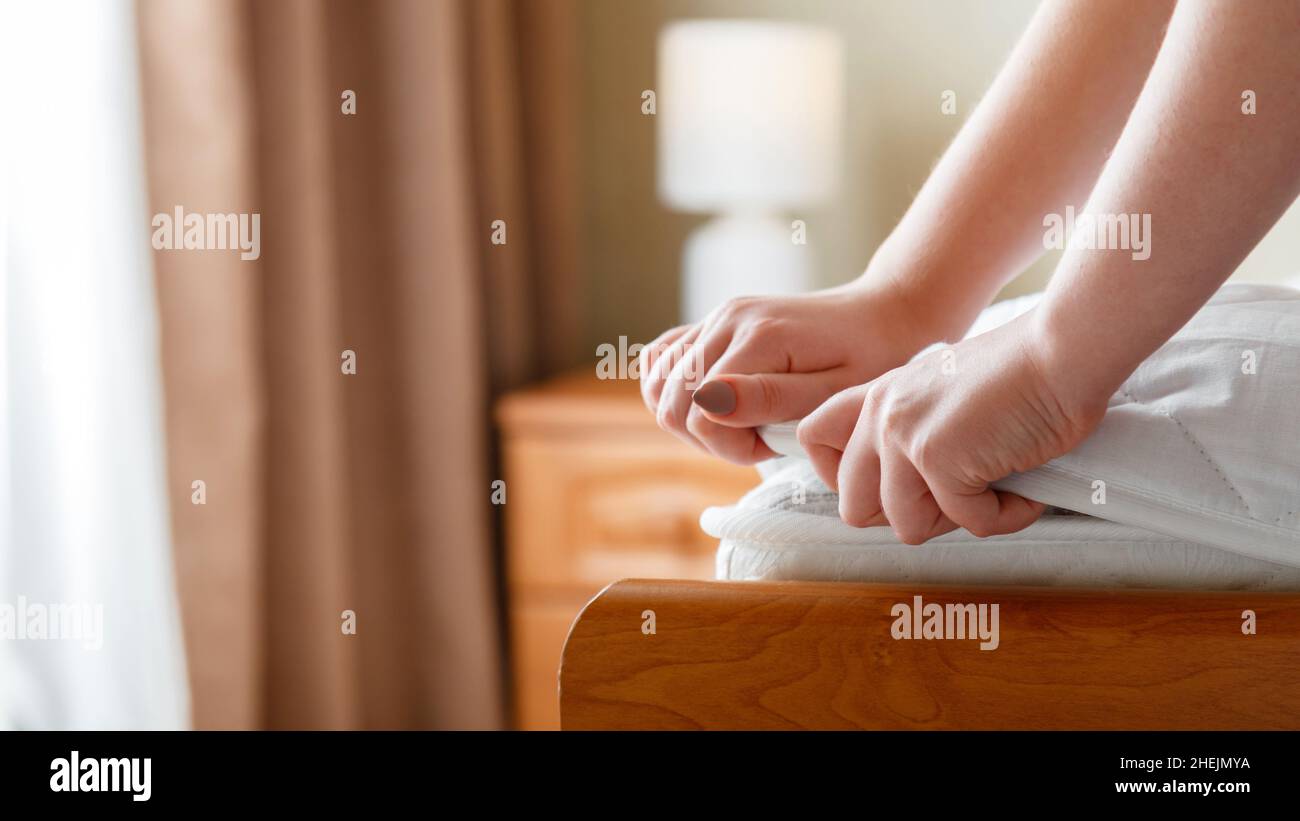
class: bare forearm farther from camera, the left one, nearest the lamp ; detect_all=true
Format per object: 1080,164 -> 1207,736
862,0 -> 1173,338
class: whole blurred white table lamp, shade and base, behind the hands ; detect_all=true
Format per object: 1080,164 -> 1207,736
657,19 -> 844,322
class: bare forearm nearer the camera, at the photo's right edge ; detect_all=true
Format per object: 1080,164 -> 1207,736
1035,0 -> 1300,410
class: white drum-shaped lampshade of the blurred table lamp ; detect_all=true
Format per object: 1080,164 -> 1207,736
655,21 -> 844,212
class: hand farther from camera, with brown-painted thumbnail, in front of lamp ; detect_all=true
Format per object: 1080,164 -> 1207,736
640,283 -> 939,465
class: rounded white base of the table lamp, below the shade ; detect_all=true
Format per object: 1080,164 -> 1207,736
681,214 -> 813,322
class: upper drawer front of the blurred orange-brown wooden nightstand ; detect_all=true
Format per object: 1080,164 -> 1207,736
506,430 -> 758,587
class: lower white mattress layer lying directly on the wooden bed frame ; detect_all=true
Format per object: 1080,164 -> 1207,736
701,459 -> 1300,590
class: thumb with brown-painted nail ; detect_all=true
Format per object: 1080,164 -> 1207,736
692,372 -> 841,427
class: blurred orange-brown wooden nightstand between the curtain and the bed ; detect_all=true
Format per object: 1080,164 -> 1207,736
497,369 -> 758,730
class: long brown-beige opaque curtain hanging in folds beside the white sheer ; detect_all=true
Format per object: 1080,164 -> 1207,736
138,0 -> 577,727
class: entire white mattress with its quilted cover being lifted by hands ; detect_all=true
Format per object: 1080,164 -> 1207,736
701,284 -> 1300,590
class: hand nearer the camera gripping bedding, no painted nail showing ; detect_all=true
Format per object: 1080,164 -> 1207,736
798,312 -> 1109,544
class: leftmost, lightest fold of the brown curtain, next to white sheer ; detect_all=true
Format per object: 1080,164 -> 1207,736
137,3 -> 265,729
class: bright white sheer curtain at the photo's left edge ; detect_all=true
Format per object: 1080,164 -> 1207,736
0,0 -> 189,729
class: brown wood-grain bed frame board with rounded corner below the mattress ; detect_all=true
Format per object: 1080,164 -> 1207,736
559,579 -> 1300,730
